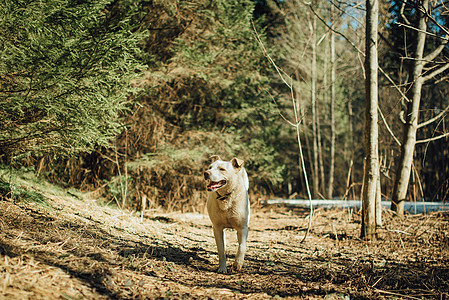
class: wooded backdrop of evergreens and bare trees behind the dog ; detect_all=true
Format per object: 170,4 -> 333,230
0,0 -> 449,211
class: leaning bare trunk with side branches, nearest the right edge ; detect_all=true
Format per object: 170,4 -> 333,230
391,0 -> 429,216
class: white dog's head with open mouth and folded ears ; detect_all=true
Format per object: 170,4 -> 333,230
204,155 -> 243,192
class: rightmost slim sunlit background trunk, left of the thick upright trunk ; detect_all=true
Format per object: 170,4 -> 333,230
327,5 -> 335,199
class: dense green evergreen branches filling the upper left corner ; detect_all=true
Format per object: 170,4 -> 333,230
0,0 -> 144,156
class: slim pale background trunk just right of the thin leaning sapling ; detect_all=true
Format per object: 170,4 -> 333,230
310,16 -> 319,197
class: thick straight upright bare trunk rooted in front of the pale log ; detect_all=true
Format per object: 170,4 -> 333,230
361,0 -> 379,239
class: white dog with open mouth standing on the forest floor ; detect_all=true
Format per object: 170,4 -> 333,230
204,155 -> 250,273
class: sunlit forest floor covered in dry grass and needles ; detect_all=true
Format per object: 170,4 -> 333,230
0,185 -> 449,299
